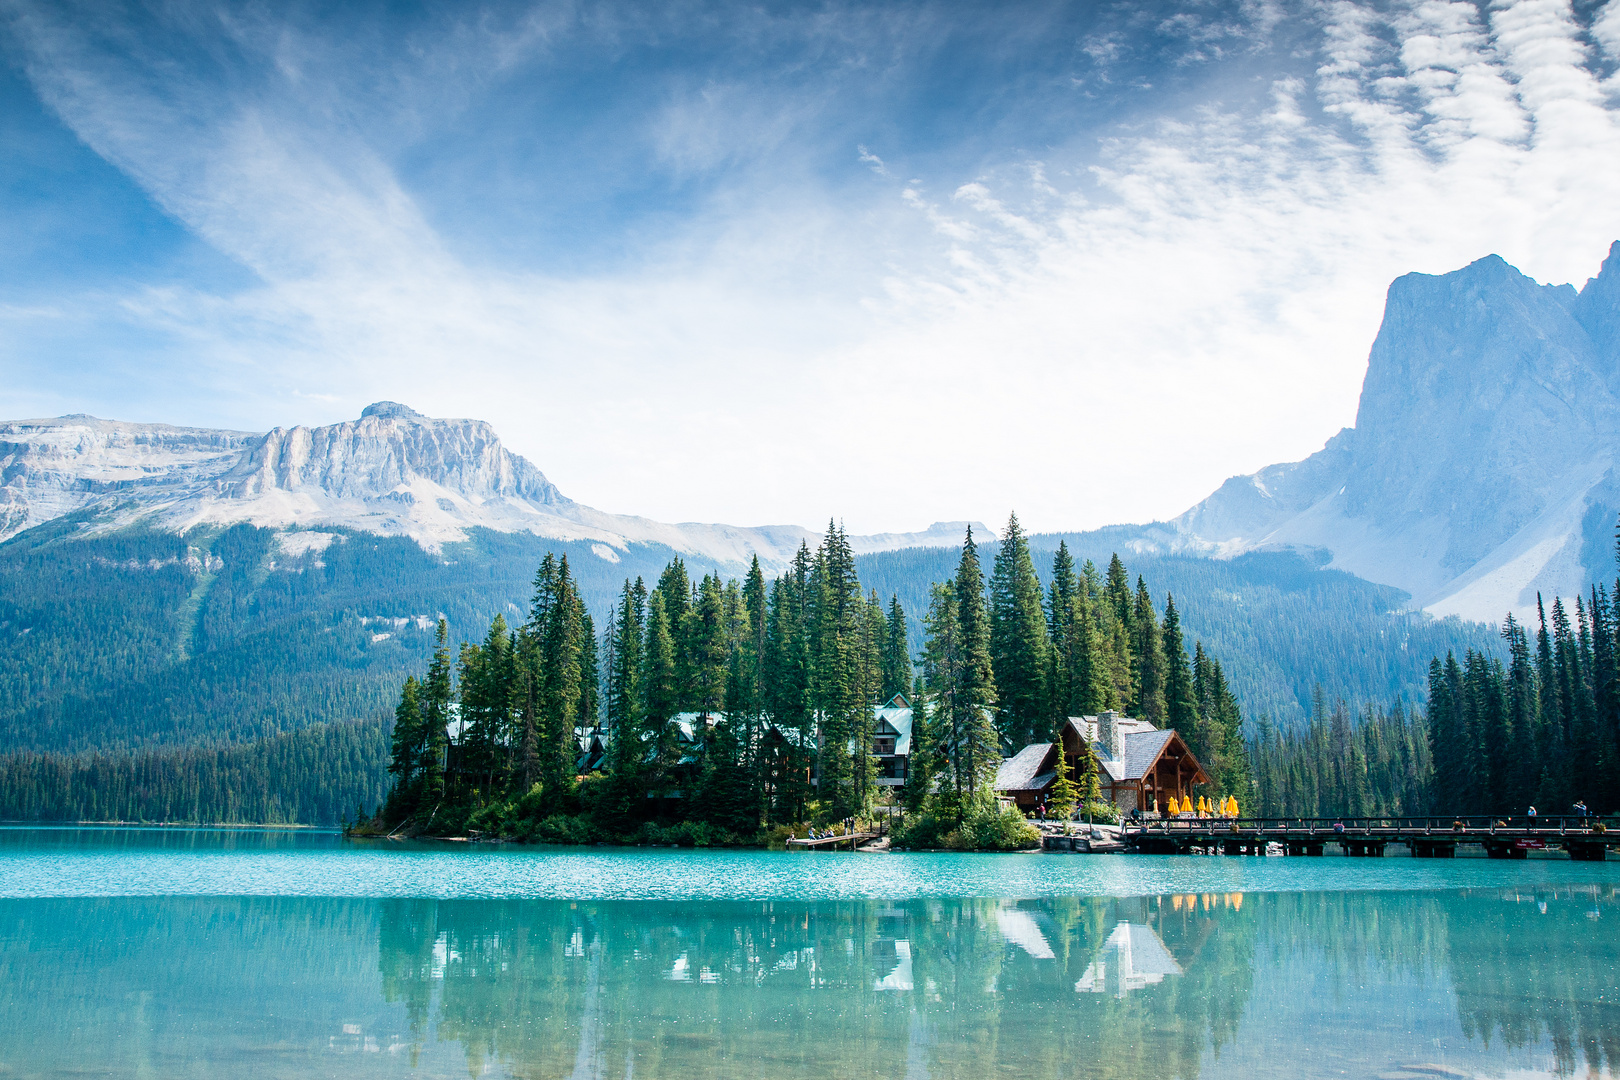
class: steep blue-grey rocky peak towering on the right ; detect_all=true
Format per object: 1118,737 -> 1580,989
1175,243 -> 1620,620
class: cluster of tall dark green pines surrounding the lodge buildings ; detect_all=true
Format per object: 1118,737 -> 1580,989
365,517 -> 1252,847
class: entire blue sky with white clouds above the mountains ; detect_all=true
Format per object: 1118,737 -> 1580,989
0,0 -> 1620,533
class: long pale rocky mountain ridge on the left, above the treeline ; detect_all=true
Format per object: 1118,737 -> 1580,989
0,402 -> 988,567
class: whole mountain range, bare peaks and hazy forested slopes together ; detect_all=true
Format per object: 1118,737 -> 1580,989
0,244 -> 1620,753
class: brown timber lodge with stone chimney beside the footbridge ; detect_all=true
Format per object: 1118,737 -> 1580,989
996,711 -> 1210,814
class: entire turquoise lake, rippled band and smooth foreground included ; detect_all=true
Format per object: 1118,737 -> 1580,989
0,829 -> 1620,1080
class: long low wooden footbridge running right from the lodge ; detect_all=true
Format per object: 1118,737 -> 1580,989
1121,816 -> 1620,863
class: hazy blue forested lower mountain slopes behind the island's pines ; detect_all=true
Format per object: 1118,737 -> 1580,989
0,517 -> 1495,751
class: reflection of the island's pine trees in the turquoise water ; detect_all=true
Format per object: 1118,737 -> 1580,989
379,899 -> 1254,1080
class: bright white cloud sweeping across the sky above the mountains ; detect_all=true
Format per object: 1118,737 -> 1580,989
3,0 -> 1620,531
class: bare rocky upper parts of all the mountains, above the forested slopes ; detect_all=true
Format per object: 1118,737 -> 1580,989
0,243 -> 1620,622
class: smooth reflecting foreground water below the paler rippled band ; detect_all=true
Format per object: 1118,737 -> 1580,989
0,889 -> 1620,1080
